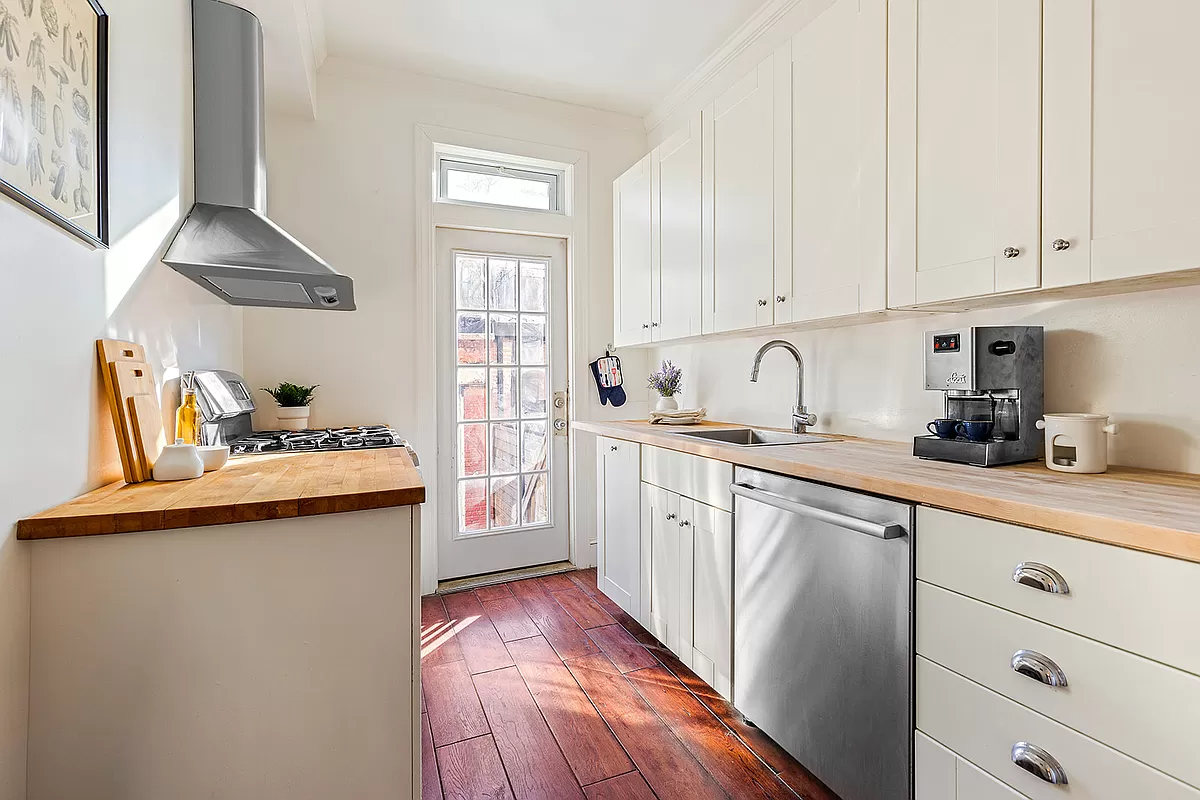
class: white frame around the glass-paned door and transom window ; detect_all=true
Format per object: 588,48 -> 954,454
410,124 -> 595,595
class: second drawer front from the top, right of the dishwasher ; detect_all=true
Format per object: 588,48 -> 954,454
917,582 -> 1200,786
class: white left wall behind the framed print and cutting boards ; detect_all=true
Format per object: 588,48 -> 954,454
0,0 -> 241,800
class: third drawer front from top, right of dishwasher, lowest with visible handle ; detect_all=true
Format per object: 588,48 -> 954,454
917,656 -> 1200,800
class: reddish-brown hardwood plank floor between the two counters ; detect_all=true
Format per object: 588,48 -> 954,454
421,570 -> 838,800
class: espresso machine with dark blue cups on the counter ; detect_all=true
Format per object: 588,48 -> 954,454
912,325 -> 1045,467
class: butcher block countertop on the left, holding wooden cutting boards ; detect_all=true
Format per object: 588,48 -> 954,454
17,447 -> 425,540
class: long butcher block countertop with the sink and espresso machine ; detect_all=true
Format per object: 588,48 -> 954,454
575,421 -> 1200,563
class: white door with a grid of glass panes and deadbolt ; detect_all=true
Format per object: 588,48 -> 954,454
437,228 -> 570,579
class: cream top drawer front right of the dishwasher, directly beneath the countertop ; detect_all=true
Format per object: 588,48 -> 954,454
917,507 -> 1200,675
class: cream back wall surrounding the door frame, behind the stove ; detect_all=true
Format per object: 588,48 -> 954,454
245,59 -> 647,582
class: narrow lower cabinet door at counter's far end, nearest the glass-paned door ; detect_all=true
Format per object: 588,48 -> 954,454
596,438 -> 642,618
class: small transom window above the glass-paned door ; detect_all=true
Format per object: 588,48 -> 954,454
438,156 -> 563,213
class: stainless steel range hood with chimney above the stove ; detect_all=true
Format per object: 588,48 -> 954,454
163,0 -> 354,311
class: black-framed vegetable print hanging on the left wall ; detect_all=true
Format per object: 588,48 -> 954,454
0,0 -> 108,247
